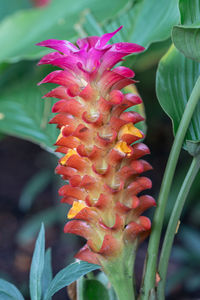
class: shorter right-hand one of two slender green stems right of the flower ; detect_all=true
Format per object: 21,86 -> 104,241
157,155 -> 200,300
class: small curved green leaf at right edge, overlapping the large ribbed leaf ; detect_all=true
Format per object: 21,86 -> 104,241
172,23 -> 200,61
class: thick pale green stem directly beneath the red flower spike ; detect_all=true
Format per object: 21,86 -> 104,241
101,245 -> 136,300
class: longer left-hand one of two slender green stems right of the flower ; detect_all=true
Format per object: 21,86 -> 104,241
140,77 -> 200,300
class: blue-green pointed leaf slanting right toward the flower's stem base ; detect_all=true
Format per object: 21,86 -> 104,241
44,261 -> 100,300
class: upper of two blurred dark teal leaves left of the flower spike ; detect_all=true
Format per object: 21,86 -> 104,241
19,170 -> 52,211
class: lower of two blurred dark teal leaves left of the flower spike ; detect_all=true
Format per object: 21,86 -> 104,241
17,204 -> 67,244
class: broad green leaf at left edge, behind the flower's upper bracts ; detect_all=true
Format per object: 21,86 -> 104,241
0,72 -> 58,152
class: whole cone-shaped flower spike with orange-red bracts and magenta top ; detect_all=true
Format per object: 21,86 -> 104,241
38,27 -> 155,264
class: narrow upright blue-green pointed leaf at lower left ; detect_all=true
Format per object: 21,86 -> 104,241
29,224 -> 45,300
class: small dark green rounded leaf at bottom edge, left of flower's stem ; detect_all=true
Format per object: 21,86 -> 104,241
83,279 -> 109,300
